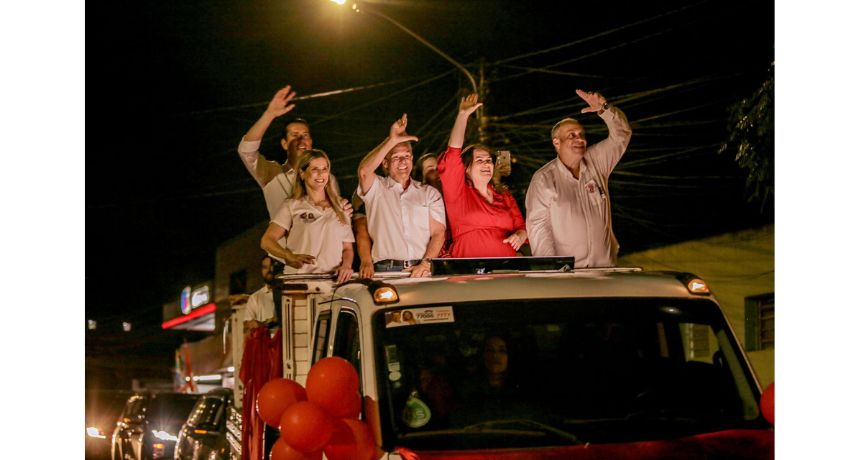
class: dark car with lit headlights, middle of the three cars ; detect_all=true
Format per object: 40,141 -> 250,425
111,393 -> 198,460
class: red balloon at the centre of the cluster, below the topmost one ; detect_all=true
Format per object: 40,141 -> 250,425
281,401 -> 334,454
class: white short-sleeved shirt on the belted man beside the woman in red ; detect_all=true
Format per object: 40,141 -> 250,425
358,176 -> 445,262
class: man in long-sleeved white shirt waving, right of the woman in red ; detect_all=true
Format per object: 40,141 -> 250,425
526,89 -> 632,267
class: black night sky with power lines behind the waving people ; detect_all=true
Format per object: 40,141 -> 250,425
85,0 -> 774,384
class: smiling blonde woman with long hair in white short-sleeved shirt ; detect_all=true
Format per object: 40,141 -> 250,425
260,149 -> 355,283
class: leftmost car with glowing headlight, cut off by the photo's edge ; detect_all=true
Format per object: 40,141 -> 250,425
84,390 -> 132,460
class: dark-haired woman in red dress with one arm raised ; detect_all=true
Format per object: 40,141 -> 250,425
438,94 -> 526,257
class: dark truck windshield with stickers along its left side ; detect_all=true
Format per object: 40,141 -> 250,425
374,299 -> 764,450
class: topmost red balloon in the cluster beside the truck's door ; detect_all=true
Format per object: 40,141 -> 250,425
307,357 -> 360,417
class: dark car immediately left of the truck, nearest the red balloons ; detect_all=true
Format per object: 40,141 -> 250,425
173,388 -> 233,460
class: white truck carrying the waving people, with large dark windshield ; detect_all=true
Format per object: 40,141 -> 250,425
222,258 -> 774,460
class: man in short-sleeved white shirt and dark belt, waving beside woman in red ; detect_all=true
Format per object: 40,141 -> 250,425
358,113 -> 445,277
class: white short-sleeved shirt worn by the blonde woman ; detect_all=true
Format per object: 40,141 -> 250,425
272,196 -> 355,273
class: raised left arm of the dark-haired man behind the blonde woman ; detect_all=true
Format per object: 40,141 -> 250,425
239,85 -> 296,187
